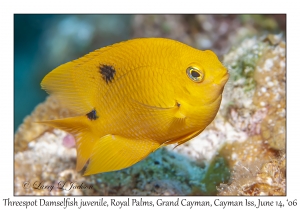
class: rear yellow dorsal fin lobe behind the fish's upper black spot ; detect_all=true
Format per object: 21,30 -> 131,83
41,51 -> 107,115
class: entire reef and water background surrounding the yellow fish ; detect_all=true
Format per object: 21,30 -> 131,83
14,14 -> 286,195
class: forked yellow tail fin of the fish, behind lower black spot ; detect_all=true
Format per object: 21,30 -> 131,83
38,116 -> 99,171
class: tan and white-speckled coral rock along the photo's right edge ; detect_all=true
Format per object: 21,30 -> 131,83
218,35 -> 286,195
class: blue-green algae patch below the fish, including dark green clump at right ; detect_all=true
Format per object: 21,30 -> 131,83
96,148 -> 230,195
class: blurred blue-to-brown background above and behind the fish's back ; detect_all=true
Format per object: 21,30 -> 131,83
14,14 -> 286,131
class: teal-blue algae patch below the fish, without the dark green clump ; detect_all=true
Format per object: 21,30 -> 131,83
96,148 -> 206,195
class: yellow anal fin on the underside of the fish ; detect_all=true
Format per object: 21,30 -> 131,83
84,134 -> 160,175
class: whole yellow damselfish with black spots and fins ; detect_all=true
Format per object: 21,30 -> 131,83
41,38 -> 229,175
